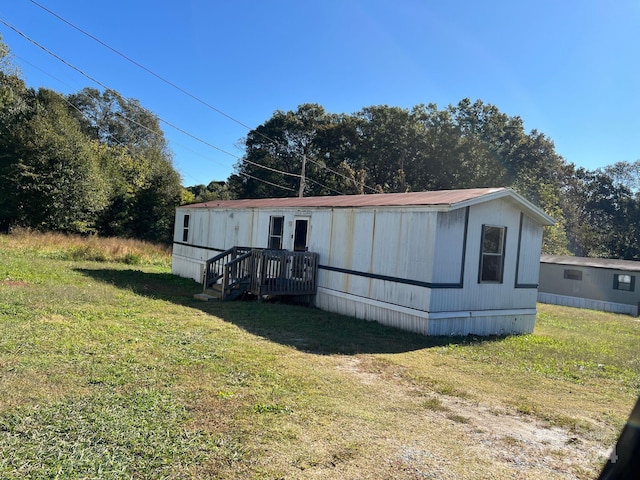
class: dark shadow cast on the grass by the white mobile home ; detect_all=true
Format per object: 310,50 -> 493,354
76,269 -> 504,355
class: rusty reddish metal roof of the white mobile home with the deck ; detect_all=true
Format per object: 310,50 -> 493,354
180,187 -> 554,225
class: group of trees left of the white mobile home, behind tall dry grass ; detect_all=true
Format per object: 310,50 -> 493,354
0,37 -> 183,242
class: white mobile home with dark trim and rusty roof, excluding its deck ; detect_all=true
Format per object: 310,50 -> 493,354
173,188 -> 553,335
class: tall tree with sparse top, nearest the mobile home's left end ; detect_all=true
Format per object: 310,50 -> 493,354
69,88 -> 182,241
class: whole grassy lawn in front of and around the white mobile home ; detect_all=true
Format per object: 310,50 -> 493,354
0,233 -> 640,479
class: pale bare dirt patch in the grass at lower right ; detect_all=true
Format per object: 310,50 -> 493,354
336,357 -> 607,479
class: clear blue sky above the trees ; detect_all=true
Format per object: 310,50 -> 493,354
0,0 -> 640,186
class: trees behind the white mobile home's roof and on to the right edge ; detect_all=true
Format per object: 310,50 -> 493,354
227,103 -> 640,259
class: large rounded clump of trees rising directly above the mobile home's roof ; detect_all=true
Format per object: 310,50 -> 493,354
234,99 -> 575,253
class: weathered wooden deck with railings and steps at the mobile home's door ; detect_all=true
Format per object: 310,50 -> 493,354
203,247 -> 318,300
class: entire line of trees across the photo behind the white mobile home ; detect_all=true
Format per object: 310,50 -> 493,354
0,34 -> 640,259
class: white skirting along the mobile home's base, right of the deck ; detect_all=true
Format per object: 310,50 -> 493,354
315,287 -> 536,336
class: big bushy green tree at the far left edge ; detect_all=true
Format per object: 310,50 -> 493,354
0,86 -> 106,233
